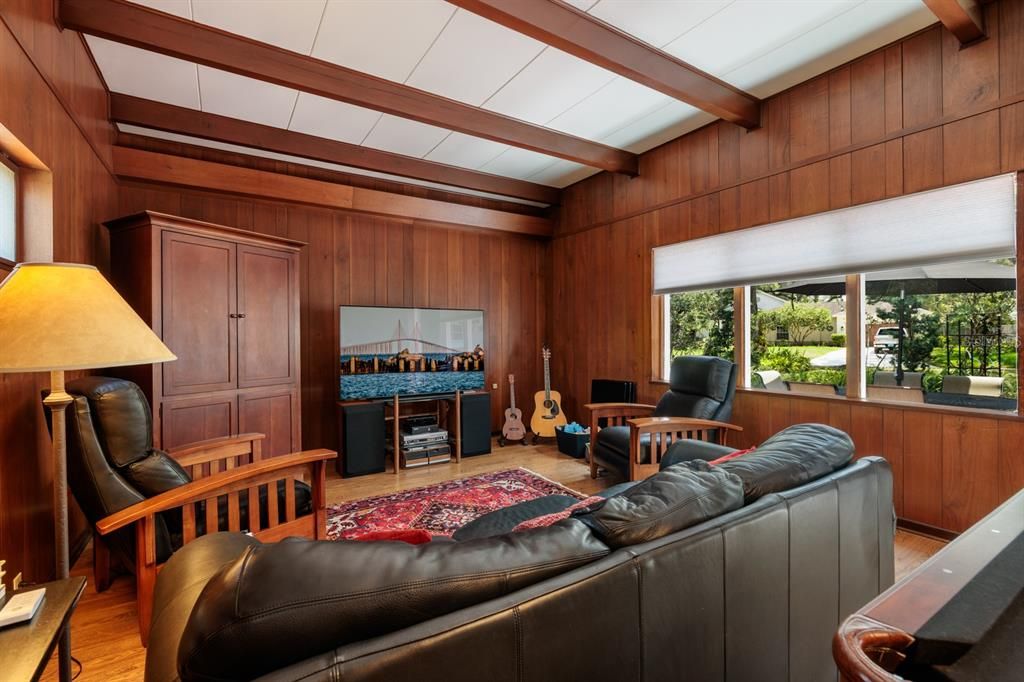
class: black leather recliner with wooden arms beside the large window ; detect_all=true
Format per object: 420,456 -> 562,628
586,356 -> 743,480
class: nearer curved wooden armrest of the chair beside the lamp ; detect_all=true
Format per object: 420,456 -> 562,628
96,449 -> 338,536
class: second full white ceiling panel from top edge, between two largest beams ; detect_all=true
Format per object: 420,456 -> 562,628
483,47 -> 616,125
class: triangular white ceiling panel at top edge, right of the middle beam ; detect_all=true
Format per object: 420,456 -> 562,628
589,0 -> 731,47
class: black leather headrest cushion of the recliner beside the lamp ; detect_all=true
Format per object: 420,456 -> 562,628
75,377 -> 153,467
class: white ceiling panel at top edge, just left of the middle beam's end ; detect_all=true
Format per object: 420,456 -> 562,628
312,0 -> 456,83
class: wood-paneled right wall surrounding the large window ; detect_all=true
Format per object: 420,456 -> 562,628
551,0 -> 1024,530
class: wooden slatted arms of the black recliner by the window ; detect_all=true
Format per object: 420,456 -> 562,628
585,402 -> 743,480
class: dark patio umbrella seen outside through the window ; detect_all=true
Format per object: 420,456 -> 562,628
775,260 -> 1017,385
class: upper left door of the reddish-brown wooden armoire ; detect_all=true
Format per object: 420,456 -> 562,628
161,231 -> 238,395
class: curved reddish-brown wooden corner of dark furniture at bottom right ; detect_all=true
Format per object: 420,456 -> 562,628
833,613 -> 913,682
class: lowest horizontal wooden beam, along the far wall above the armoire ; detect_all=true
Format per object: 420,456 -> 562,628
114,146 -> 553,237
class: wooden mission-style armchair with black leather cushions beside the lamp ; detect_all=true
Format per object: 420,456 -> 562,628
55,377 -> 336,646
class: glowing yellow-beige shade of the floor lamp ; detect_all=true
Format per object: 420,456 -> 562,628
0,263 -> 177,372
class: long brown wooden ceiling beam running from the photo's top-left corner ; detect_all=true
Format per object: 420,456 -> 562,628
59,0 -> 639,175
